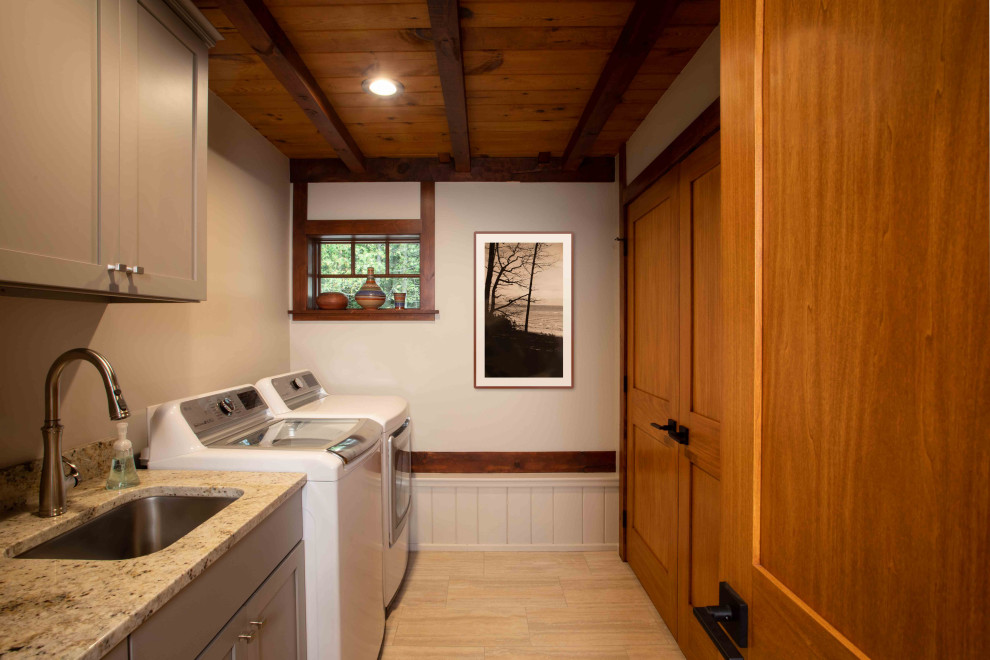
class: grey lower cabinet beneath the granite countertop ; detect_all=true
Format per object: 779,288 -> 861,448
122,492 -> 306,660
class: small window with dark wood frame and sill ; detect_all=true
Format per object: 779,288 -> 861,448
290,182 -> 438,321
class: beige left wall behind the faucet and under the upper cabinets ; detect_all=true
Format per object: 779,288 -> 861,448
0,93 -> 290,466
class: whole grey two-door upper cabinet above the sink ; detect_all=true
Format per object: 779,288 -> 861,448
0,0 -> 217,300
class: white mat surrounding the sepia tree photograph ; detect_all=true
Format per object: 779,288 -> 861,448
474,232 -> 574,387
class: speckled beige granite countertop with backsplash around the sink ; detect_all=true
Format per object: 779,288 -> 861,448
0,470 -> 306,660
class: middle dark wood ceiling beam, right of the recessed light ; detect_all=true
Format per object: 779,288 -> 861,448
428,0 -> 471,172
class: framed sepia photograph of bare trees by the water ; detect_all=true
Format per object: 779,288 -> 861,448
474,232 -> 574,387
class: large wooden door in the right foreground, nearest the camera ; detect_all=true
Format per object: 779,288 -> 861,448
713,0 -> 990,660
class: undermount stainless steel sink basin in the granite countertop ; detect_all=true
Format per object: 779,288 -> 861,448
16,495 -> 237,560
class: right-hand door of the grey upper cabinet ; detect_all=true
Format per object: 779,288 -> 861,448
120,0 -> 208,299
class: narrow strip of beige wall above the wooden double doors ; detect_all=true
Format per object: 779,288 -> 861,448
626,27 -> 721,183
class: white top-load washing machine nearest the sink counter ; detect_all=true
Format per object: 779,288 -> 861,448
148,385 -> 385,660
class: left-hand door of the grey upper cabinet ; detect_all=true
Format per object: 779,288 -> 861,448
0,0 -> 119,290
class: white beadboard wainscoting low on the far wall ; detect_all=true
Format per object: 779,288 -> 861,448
409,473 -> 620,551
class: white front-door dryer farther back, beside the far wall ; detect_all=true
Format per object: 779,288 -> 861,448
255,371 -> 412,607
